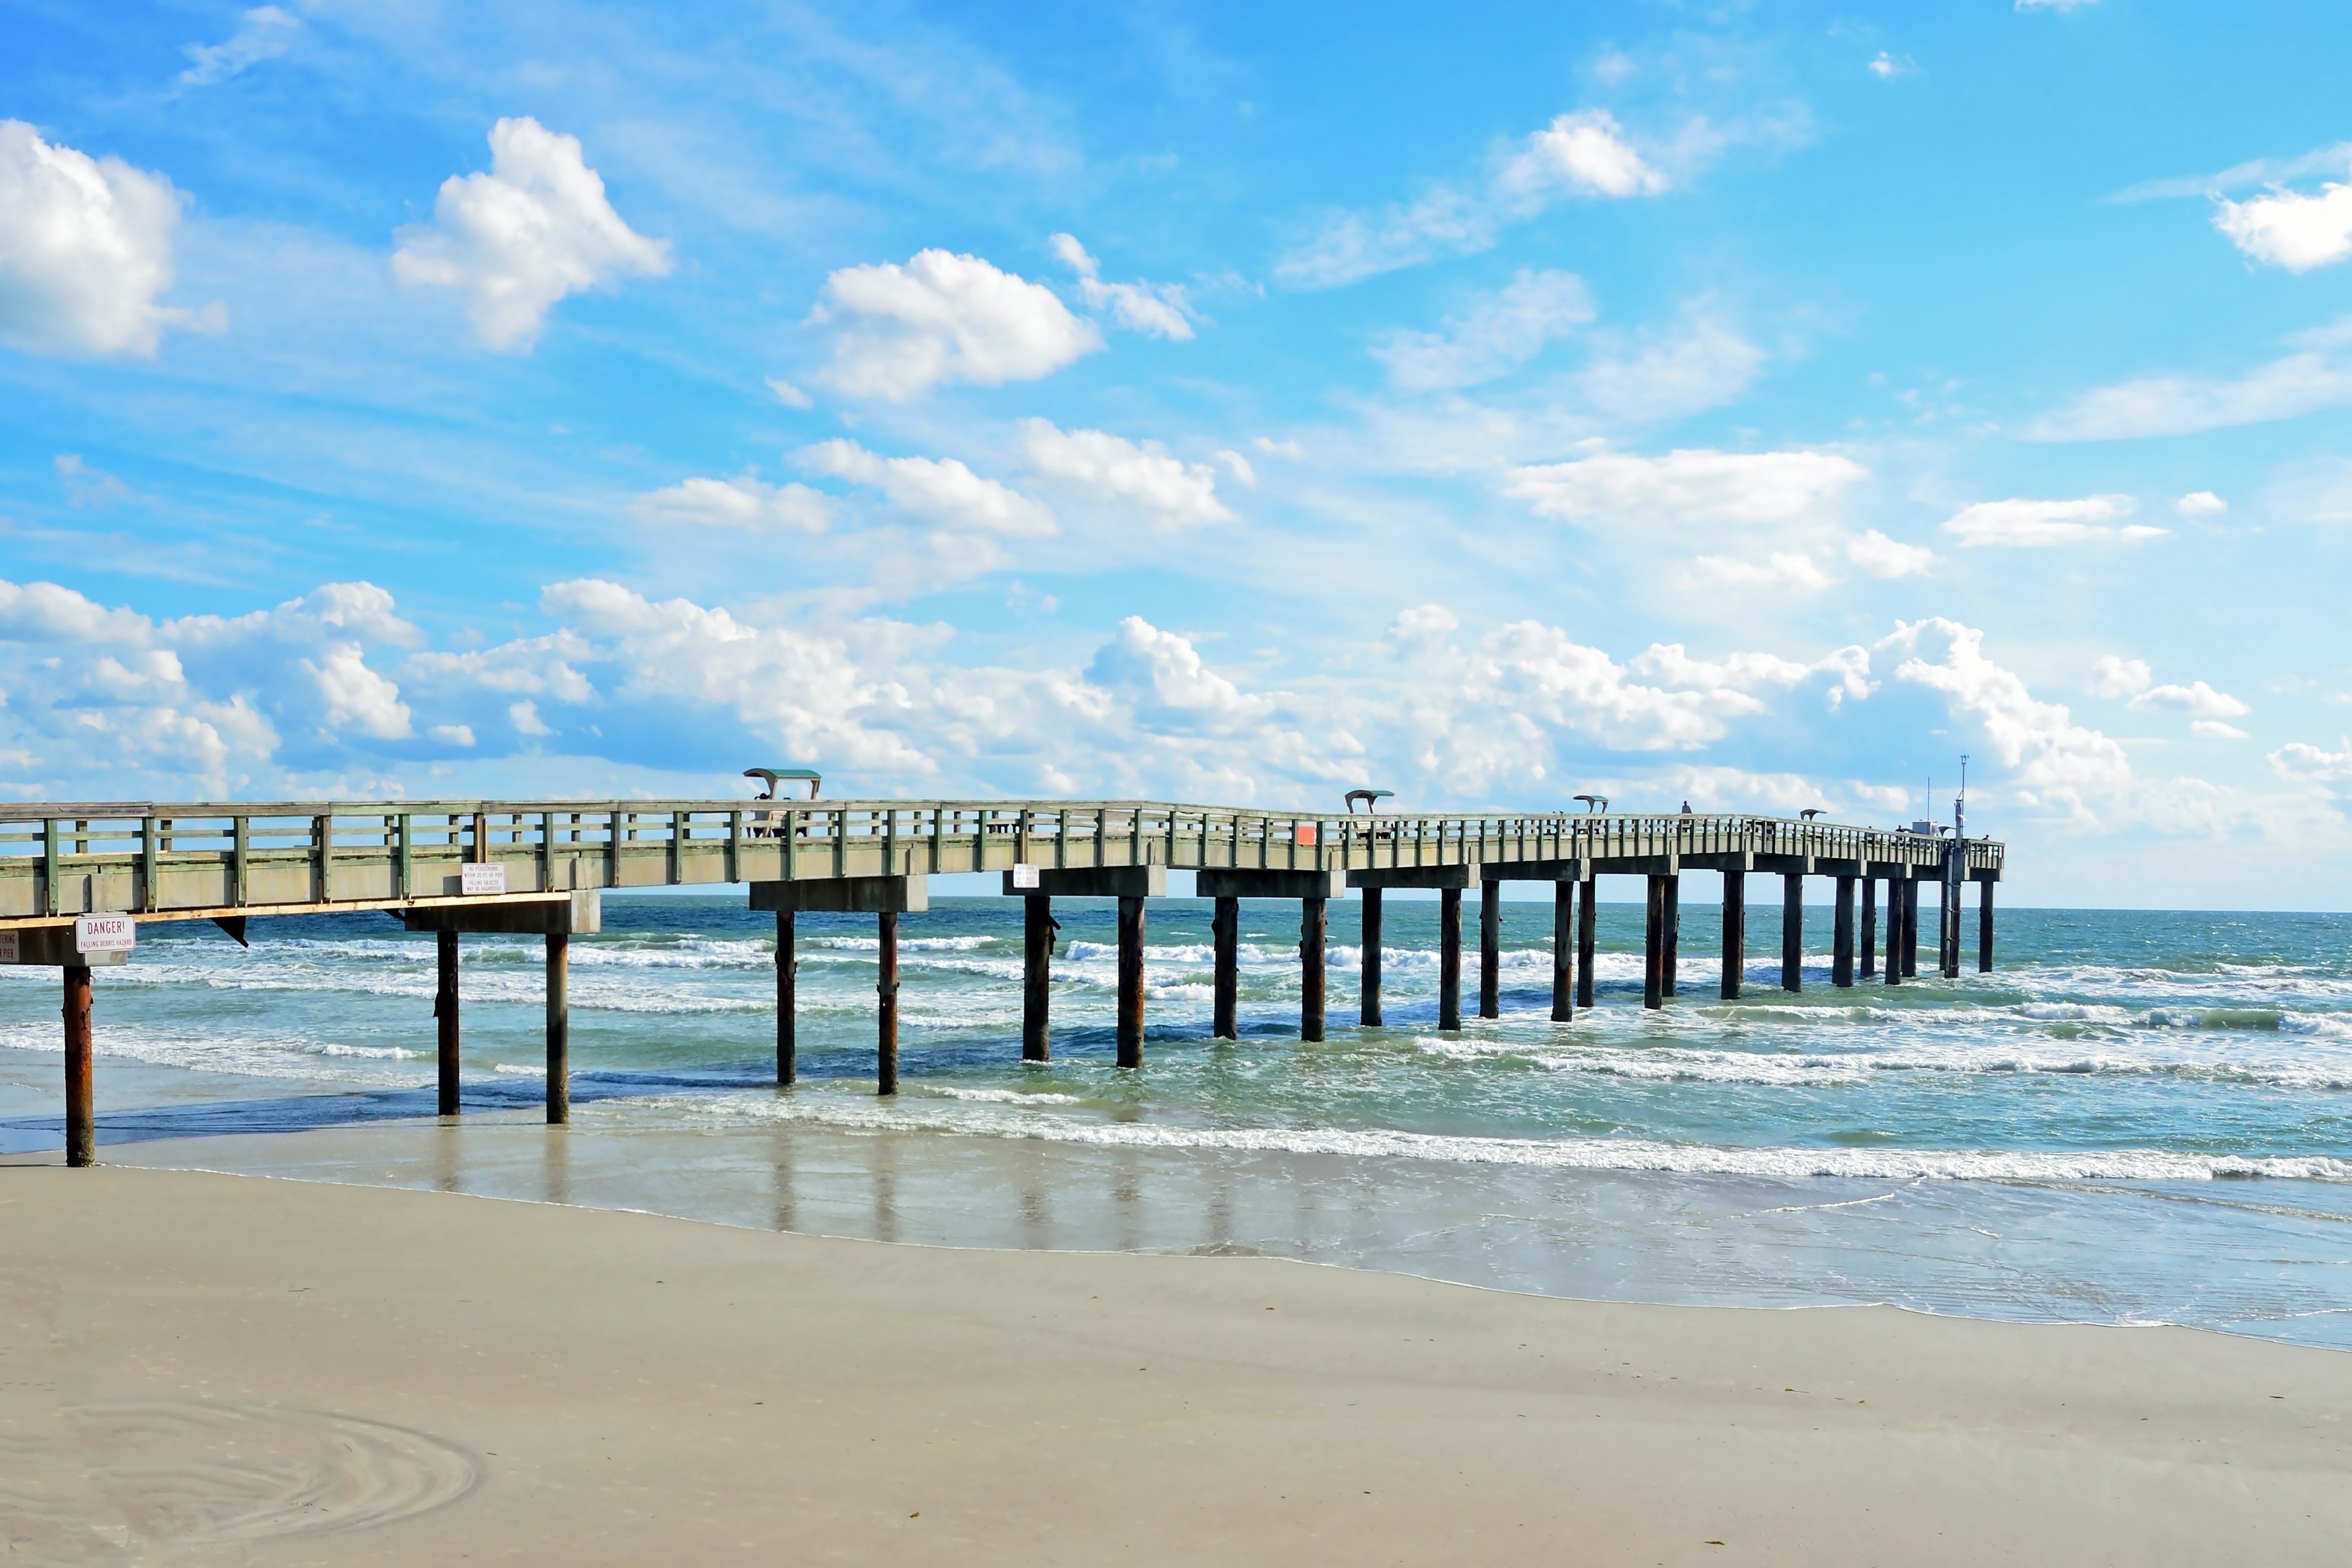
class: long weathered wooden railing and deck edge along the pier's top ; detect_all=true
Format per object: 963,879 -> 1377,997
0,799 -> 2002,924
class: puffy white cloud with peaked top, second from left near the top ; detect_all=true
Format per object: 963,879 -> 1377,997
393,115 -> 670,350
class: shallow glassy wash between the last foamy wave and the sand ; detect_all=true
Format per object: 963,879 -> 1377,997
5,1110 -> 2352,1349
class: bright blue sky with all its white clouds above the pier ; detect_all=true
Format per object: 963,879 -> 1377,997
0,0 -> 2352,908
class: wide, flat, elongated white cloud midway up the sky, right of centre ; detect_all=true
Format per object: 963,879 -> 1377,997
1505,449 -> 1868,525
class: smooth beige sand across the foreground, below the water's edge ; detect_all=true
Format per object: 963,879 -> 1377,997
0,1166 -> 2352,1568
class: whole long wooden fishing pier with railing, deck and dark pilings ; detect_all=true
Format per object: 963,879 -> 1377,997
0,799 -> 2002,1166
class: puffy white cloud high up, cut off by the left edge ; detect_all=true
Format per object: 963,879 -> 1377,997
0,120 -> 228,355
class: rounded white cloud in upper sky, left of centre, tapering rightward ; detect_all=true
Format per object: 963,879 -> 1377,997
809,249 -> 1103,402
